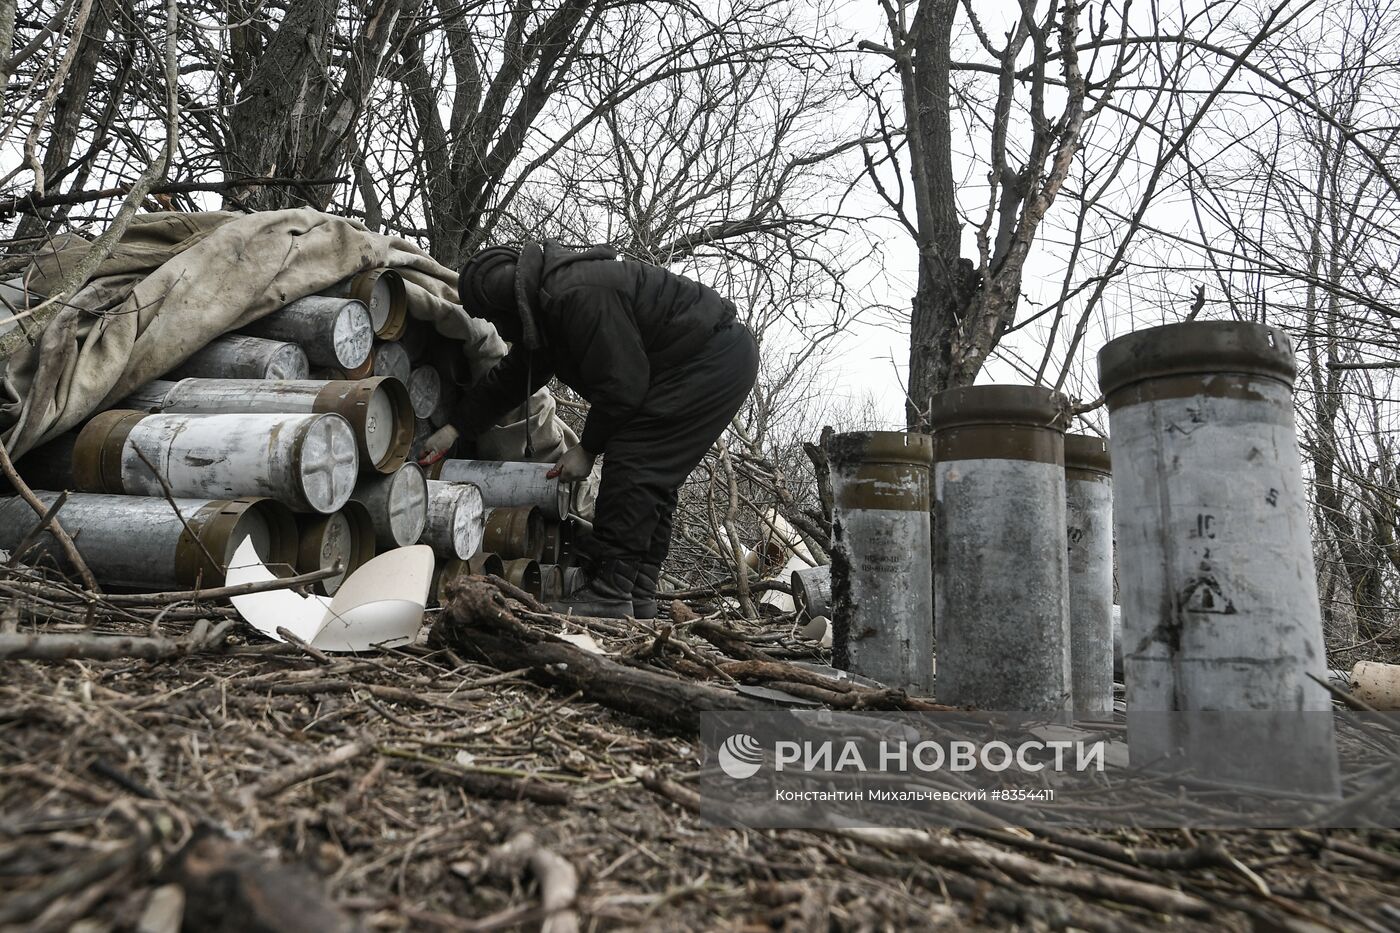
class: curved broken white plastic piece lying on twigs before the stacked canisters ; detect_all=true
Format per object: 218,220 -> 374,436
224,541 -> 433,651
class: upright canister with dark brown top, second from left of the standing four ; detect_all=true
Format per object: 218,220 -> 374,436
928,385 -> 1071,712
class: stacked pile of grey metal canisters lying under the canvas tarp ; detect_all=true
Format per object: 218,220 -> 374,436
0,269 -> 578,598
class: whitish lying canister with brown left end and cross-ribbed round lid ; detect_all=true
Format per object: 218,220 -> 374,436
73,409 -> 360,513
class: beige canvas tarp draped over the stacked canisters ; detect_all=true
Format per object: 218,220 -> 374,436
0,209 -> 577,461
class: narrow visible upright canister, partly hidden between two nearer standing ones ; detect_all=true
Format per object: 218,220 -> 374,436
1064,434 -> 1113,714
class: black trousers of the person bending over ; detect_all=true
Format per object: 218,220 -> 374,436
585,322 -> 759,566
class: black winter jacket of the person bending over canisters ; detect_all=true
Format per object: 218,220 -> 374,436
462,244 -> 735,455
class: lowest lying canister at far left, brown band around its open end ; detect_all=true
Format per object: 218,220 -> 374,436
0,492 -> 297,588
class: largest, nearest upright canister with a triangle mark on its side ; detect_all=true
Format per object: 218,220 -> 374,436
1099,321 -> 1337,794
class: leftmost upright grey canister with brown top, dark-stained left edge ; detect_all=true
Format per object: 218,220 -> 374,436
827,431 -> 934,696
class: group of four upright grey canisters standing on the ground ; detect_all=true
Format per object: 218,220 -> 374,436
827,322 -> 1337,793
